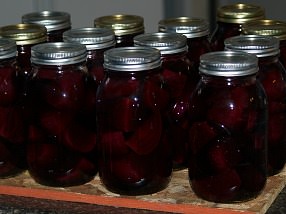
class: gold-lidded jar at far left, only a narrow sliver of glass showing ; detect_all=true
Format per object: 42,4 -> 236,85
0,24 -> 47,95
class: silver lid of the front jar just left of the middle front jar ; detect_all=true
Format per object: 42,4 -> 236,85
31,42 -> 87,65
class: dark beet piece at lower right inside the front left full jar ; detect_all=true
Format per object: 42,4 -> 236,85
62,122 -> 96,153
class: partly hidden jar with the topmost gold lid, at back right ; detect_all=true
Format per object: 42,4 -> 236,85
210,3 -> 265,51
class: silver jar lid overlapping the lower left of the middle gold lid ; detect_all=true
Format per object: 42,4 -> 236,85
63,28 -> 115,50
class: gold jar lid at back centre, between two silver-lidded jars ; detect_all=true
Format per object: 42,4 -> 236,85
94,14 -> 144,36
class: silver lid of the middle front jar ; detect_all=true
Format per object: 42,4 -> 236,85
103,47 -> 161,72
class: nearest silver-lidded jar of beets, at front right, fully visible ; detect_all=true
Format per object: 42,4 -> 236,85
188,51 -> 267,203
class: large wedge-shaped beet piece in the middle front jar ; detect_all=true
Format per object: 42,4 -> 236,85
126,111 -> 162,155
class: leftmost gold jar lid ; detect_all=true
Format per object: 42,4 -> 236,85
0,24 -> 47,45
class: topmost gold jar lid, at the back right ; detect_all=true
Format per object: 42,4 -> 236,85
217,4 -> 265,24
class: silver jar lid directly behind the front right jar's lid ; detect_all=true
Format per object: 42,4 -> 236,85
224,35 -> 280,58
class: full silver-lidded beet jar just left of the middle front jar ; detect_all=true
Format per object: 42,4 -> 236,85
27,42 -> 97,187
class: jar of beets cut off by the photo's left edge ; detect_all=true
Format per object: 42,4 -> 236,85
0,38 -> 26,178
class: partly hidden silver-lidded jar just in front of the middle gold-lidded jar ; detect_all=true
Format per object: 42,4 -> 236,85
63,28 -> 115,84
